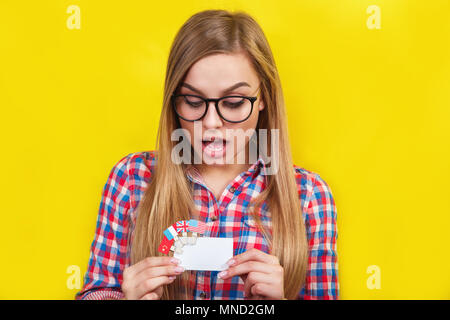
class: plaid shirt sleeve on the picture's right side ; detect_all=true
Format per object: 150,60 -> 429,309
299,173 -> 339,300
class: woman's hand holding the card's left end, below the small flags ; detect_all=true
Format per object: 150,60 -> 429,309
122,257 -> 184,300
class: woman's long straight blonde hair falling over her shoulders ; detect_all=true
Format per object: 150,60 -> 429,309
130,10 -> 308,299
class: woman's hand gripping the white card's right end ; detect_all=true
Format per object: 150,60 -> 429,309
218,248 -> 284,300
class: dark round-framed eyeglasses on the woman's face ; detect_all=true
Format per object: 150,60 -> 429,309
171,87 -> 259,123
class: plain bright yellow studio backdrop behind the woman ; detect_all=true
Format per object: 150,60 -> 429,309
0,0 -> 450,299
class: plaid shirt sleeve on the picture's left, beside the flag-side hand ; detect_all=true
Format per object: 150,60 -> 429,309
75,156 -> 130,300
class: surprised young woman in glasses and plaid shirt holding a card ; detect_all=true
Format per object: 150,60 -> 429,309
76,10 -> 339,299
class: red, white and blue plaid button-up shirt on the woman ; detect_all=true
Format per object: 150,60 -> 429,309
75,151 -> 339,300
